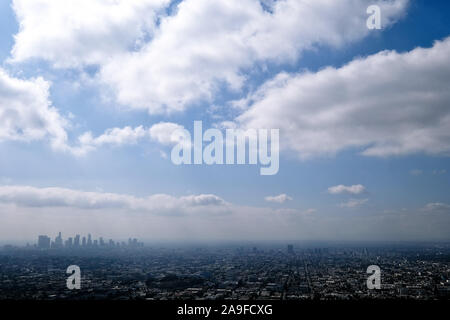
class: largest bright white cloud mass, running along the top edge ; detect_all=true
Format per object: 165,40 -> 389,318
12,0 -> 408,113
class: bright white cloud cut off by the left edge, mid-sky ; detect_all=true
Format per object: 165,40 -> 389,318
0,68 -> 68,149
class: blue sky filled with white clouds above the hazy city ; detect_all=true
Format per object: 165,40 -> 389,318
0,0 -> 450,242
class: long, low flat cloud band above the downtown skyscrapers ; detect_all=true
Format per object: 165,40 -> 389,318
0,186 -> 228,214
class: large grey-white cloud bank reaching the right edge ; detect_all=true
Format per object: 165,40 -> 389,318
237,38 -> 450,159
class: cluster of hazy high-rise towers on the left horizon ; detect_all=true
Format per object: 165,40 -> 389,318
37,232 -> 144,249
